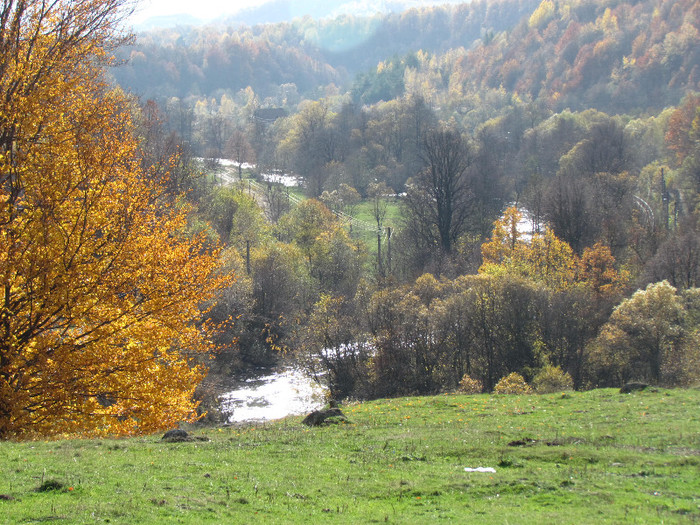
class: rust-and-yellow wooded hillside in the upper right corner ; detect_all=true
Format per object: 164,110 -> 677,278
455,0 -> 700,114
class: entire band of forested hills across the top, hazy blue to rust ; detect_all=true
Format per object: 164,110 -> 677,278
114,0 -> 700,114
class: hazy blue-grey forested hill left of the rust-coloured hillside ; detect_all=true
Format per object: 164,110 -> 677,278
113,0 -> 537,100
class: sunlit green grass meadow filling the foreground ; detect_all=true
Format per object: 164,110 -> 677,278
0,390 -> 700,524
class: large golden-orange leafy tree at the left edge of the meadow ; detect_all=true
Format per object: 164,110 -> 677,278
0,0 -> 232,439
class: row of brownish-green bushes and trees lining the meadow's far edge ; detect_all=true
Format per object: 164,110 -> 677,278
299,249 -> 700,399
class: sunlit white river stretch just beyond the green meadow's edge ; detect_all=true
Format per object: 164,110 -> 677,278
219,367 -> 326,423
